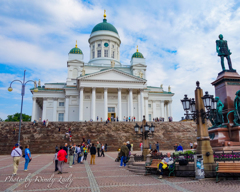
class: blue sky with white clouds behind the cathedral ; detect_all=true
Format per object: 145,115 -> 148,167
0,0 -> 240,121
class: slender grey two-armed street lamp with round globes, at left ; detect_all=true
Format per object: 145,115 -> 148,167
8,70 -> 38,145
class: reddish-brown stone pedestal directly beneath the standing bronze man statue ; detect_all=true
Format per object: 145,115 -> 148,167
212,71 -> 240,123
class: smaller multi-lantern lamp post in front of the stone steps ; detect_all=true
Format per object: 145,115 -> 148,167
134,115 -> 155,161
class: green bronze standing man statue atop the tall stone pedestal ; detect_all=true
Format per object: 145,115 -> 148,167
216,34 -> 235,71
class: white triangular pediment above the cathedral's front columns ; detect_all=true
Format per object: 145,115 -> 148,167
79,69 -> 146,82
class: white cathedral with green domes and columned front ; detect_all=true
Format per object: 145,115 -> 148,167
31,14 -> 174,121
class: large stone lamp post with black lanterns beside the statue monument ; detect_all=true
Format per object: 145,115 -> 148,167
181,81 -> 216,171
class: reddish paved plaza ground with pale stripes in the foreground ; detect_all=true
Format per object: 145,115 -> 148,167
0,152 -> 240,192
